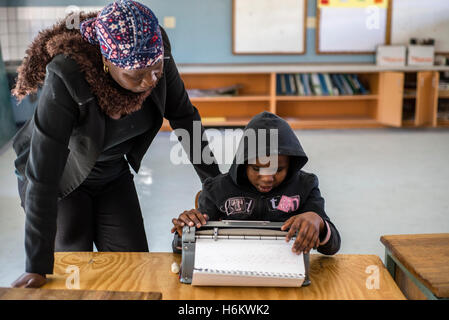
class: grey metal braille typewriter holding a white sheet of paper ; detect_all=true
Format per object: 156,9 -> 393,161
174,220 -> 310,287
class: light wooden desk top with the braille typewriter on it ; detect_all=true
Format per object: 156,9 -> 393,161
44,252 -> 404,300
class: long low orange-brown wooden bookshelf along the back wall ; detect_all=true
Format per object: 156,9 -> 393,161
162,65 -> 449,130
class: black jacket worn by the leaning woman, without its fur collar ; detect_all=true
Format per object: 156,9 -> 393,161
13,33 -> 220,274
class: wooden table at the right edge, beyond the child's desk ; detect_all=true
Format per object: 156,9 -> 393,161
380,233 -> 449,300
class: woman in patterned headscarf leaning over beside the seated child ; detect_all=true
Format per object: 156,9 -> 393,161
12,0 -> 219,287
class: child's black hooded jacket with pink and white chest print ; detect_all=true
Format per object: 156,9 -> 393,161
198,112 -> 340,255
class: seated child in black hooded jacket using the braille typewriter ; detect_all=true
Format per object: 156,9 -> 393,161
171,112 -> 340,255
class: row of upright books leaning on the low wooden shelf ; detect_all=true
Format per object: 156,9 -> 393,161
276,73 -> 369,96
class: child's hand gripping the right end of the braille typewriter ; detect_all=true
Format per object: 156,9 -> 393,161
281,211 -> 324,254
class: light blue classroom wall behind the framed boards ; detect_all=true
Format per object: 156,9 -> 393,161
0,0 -> 375,64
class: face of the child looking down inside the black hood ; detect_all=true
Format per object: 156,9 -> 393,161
246,155 -> 290,193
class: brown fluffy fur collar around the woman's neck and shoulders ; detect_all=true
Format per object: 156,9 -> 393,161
12,13 -> 150,116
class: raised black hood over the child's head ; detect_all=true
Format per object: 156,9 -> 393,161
229,111 -> 308,185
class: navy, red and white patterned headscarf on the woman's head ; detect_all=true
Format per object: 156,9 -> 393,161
80,0 -> 164,70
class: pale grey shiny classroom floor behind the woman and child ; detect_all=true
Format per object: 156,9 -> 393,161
0,129 -> 449,286
